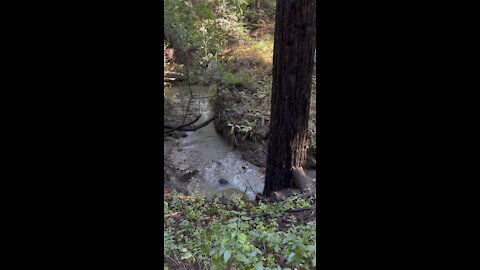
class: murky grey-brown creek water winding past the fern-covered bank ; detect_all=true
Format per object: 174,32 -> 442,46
164,86 -> 265,200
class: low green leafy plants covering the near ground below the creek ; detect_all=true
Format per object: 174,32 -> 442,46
164,191 -> 316,269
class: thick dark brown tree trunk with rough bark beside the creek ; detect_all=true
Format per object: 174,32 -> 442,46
264,0 -> 316,196
